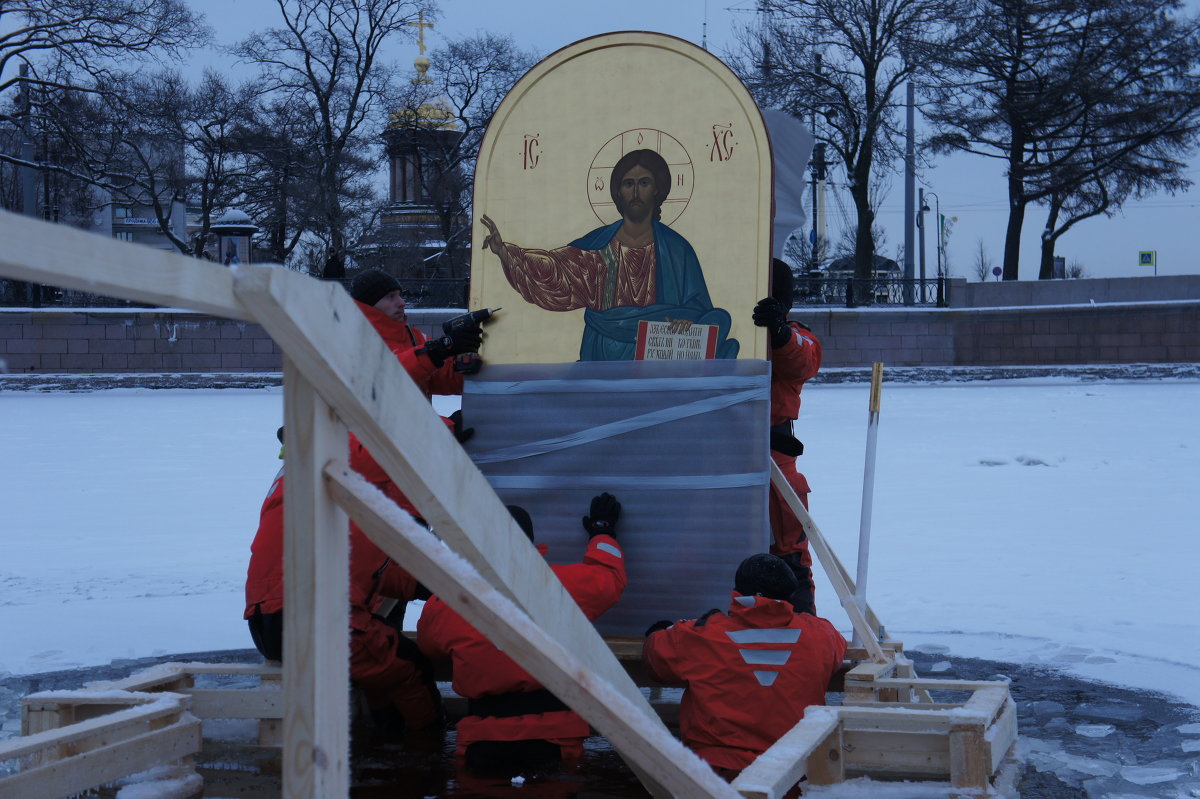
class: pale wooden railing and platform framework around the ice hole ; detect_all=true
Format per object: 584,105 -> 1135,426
0,212 -> 1016,799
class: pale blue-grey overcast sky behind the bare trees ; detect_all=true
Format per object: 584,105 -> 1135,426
182,0 -> 1200,280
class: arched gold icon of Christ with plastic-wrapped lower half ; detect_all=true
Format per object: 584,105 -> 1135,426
462,31 -> 773,636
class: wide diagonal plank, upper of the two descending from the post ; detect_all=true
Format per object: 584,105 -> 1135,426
226,266 -> 676,753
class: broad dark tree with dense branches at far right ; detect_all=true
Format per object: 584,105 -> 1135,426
926,0 -> 1200,280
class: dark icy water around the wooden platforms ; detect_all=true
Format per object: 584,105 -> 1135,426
0,650 -> 1200,799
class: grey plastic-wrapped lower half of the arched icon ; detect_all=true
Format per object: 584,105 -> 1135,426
462,359 -> 770,636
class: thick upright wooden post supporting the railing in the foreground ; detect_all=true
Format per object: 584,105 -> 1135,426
283,364 -> 350,799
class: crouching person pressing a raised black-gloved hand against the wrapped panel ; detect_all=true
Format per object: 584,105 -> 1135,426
416,493 -> 625,774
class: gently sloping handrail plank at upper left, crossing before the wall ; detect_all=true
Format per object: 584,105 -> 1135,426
0,211 -> 251,319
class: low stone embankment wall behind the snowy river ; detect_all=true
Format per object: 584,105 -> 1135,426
0,275 -> 1200,373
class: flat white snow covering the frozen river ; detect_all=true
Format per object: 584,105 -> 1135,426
0,372 -> 1200,715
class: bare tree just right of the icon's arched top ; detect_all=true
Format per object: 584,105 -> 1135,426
734,0 -> 959,297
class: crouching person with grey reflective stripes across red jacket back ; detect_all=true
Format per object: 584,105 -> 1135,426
642,554 -> 846,779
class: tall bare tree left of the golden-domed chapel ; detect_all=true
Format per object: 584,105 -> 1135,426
235,0 -> 431,278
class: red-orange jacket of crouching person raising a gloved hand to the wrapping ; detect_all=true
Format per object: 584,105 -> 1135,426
416,535 -> 625,758
